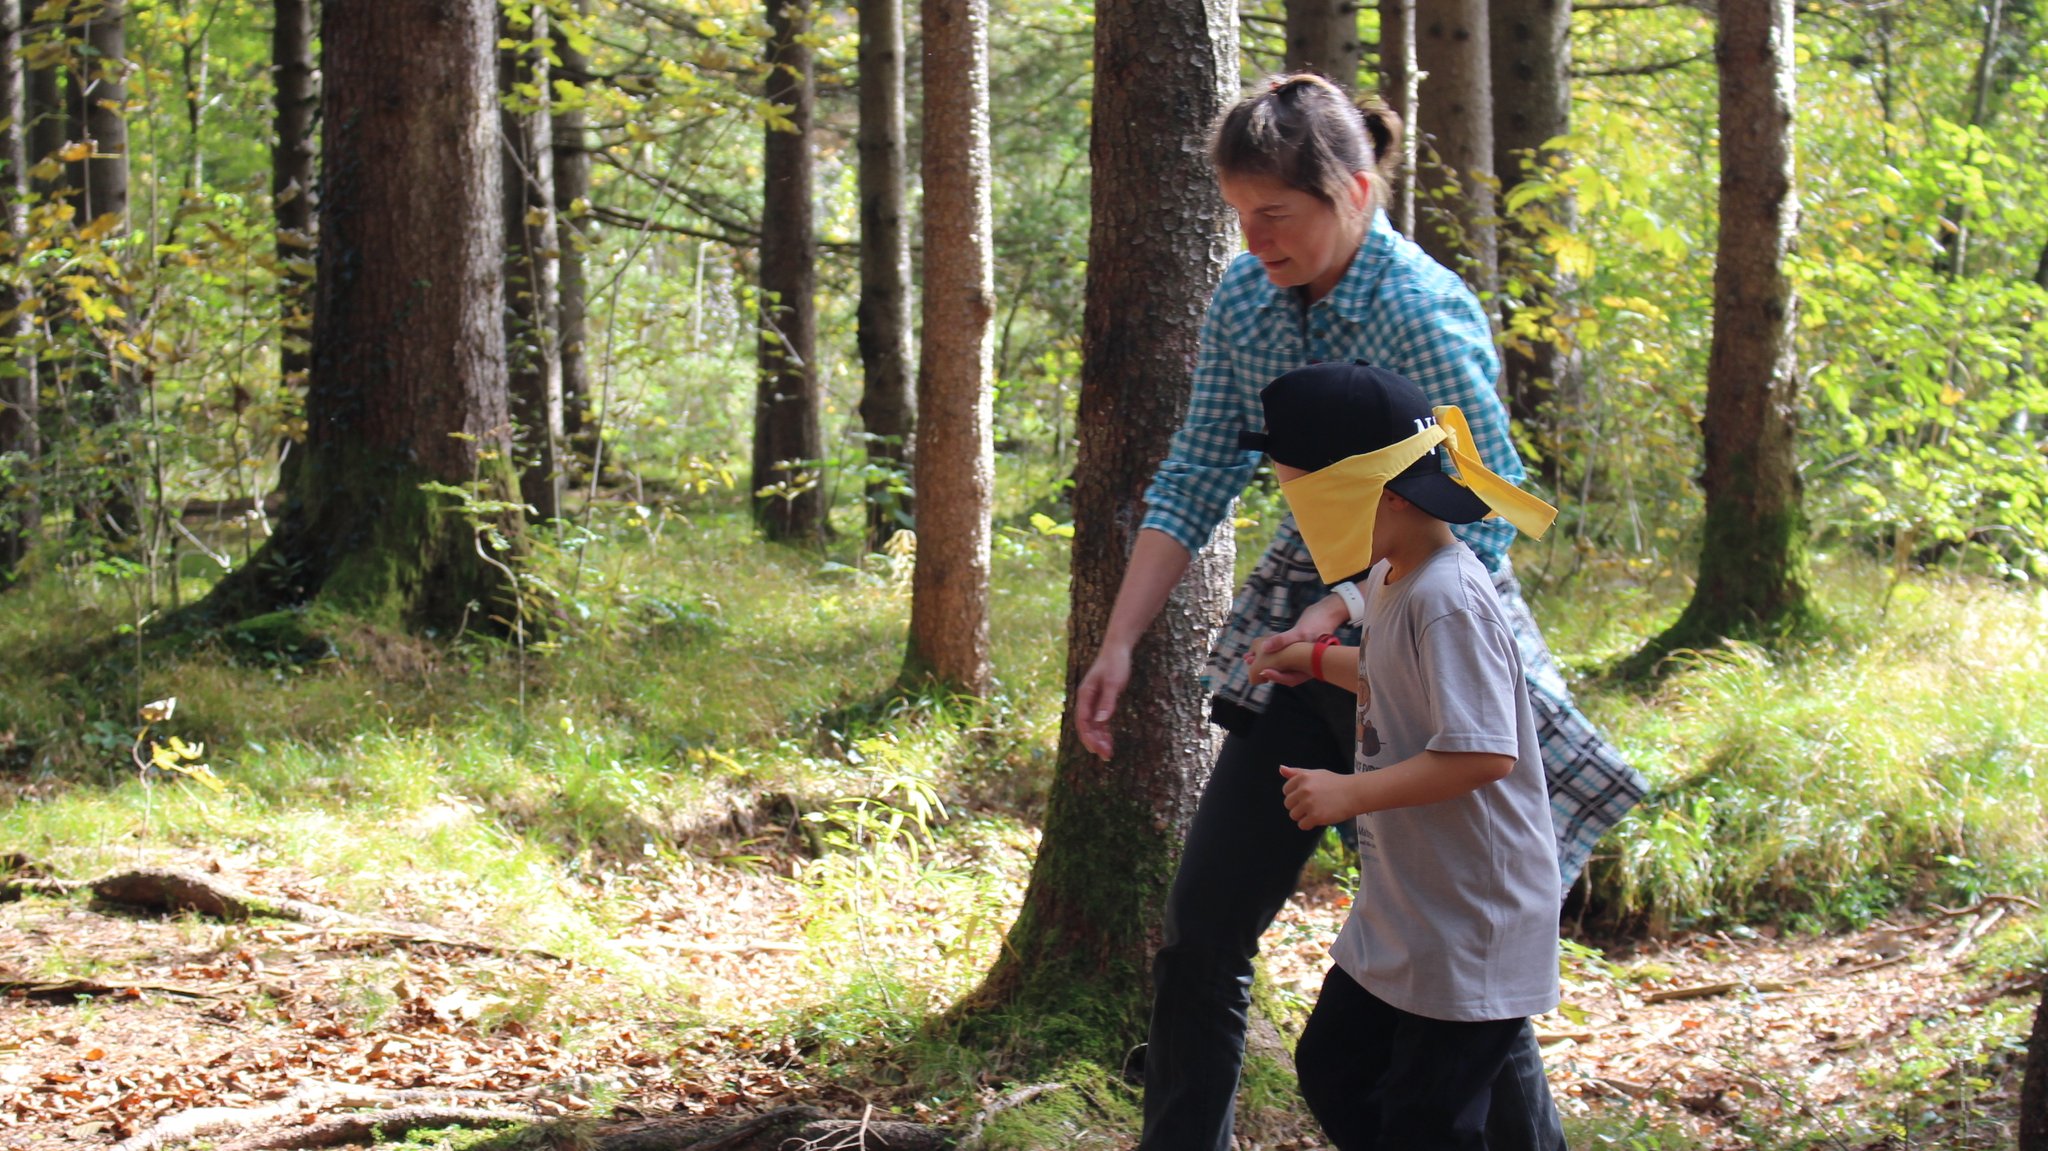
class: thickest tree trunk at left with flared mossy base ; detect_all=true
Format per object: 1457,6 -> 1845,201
199,0 -> 520,631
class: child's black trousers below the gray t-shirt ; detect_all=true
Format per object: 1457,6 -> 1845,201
1294,967 -> 1528,1151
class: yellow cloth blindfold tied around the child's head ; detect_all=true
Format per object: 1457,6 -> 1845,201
1280,406 -> 1556,584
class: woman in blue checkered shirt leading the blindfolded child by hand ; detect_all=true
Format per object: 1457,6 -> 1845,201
1075,76 -> 1642,1151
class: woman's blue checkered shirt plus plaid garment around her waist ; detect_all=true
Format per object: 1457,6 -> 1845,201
1141,213 -> 1642,887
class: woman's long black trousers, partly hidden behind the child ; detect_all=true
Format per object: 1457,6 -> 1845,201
1139,682 -> 1565,1151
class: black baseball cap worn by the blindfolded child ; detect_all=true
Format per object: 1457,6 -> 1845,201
1237,360 -> 1491,524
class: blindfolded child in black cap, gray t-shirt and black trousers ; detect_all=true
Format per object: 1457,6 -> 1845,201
1251,365 -> 1559,1151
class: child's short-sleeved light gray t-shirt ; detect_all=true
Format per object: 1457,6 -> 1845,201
1331,543 -> 1559,1020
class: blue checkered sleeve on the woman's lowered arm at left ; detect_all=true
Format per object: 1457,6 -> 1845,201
1139,268 -> 1261,555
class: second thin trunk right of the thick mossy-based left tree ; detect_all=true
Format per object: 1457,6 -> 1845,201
555,0 -> 598,467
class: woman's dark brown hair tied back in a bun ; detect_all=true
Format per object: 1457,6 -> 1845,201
1208,72 -> 1401,207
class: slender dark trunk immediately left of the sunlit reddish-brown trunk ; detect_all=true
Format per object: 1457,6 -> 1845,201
860,0 -> 918,551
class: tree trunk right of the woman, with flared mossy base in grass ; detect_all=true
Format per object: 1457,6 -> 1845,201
1626,0 -> 1808,672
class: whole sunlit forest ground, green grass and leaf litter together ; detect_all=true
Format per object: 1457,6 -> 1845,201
0,487 -> 2048,1149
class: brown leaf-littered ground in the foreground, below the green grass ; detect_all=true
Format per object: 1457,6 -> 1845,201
0,839 -> 2036,1151
